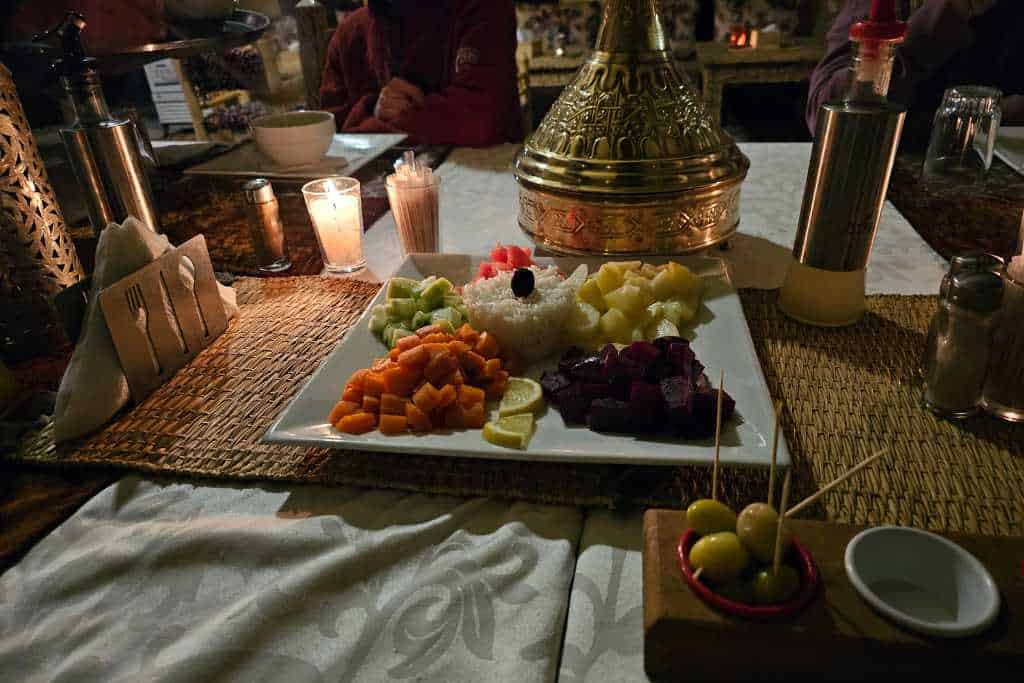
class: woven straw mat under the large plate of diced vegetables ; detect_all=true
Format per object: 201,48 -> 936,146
13,278 -> 1024,535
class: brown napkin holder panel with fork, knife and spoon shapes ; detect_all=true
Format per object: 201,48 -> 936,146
99,234 -> 227,403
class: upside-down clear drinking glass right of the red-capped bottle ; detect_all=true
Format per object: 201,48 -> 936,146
924,85 -> 1002,181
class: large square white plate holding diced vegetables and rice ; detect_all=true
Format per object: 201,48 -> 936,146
264,254 -> 790,466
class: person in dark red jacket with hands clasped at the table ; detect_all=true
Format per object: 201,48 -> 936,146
321,0 -> 521,146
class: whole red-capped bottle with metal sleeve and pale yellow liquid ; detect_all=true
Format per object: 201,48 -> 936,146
779,0 -> 906,327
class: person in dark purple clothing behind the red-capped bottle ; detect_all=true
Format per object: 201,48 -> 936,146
807,0 -> 1024,147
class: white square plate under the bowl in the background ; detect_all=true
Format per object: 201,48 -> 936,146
184,133 -> 406,180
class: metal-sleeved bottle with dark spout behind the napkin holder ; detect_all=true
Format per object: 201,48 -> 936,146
47,11 -> 159,232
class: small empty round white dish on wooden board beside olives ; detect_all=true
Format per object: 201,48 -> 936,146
847,528 -> 999,638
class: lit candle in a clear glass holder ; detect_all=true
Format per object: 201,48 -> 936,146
302,177 -> 367,272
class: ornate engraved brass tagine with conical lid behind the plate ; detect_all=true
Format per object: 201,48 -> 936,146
515,0 -> 750,254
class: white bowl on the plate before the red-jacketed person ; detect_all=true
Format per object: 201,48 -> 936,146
249,112 -> 335,167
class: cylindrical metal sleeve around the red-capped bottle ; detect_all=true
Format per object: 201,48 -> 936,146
793,101 -> 906,272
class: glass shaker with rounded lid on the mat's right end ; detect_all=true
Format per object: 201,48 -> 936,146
923,270 -> 1002,420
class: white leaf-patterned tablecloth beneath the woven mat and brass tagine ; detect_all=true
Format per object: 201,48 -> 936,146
0,143 -> 944,683
